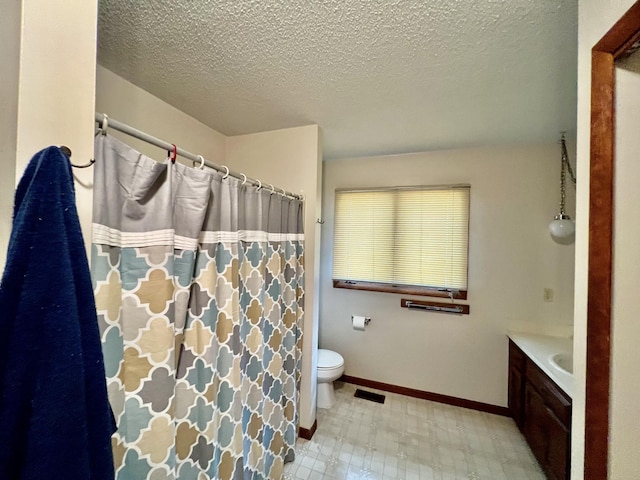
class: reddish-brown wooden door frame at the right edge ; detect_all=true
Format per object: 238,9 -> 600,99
584,0 -> 640,480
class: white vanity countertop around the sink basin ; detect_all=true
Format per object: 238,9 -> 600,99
507,332 -> 574,398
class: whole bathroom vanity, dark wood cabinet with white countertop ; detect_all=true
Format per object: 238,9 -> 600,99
509,334 -> 573,480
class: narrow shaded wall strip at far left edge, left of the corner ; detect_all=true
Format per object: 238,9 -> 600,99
0,0 -> 21,272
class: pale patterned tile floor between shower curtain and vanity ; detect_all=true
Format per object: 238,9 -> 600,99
284,382 -> 545,480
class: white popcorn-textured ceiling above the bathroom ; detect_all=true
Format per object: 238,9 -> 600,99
98,0 -> 578,159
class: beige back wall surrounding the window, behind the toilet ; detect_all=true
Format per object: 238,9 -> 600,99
320,144 -> 574,406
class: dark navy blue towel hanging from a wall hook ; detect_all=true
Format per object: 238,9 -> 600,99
0,147 -> 115,480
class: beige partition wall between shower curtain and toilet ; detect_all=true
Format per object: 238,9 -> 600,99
226,125 -> 322,429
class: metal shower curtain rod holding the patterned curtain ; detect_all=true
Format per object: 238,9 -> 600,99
95,112 -> 304,200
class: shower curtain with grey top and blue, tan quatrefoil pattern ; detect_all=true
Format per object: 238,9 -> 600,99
92,135 -> 304,480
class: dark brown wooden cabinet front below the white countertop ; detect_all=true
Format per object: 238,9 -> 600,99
509,341 -> 571,480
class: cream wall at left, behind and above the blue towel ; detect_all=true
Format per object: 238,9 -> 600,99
0,0 -> 97,267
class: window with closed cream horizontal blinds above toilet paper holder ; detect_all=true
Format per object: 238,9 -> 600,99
333,185 -> 470,299
